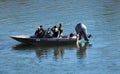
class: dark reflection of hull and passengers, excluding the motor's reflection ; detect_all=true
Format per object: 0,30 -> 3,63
13,44 -> 76,59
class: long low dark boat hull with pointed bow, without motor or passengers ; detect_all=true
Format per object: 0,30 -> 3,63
11,35 -> 77,45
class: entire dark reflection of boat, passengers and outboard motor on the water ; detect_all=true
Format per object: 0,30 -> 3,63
13,42 -> 89,60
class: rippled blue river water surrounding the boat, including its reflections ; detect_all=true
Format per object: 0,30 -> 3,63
0,0 -> 120,74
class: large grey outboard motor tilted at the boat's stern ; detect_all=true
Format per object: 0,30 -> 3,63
75,23 -> 91,41
